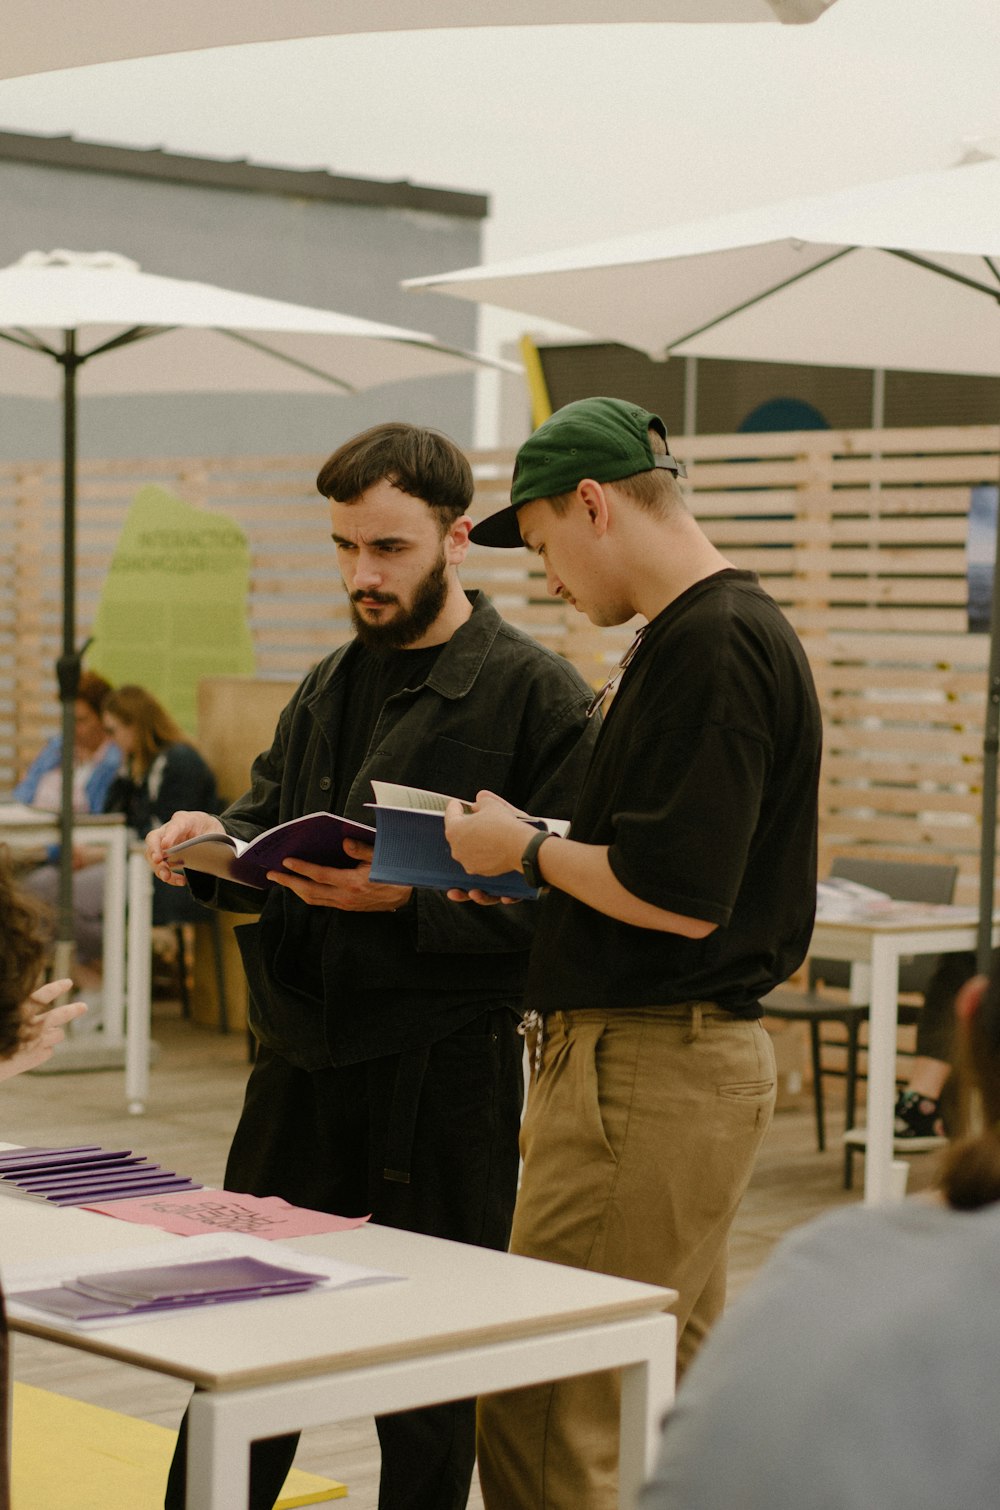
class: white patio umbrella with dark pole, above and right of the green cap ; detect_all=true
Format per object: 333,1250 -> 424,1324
406,160 -> 1000,966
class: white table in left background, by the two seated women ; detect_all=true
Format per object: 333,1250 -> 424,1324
0,802 -> 153,1111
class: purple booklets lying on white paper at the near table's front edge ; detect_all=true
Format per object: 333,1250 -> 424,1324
18,1255 -> 326,1321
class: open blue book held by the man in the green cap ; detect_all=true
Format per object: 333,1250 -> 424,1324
372,781 -> 569,900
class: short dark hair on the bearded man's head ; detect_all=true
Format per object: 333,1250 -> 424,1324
316,421 -> 473,527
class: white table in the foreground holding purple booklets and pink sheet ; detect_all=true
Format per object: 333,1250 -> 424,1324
0,1194 -> 677,1510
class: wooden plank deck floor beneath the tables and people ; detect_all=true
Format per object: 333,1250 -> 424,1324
2,1003 -> 934,1510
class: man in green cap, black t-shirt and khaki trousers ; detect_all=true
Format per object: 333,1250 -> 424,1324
446,399 -> 820,1510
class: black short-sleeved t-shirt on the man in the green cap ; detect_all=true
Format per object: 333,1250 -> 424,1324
526,571 -> 822,1018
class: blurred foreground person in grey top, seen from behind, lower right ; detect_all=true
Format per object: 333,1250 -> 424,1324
642,959 -> 1000,1510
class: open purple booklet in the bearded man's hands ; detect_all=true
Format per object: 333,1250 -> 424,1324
166,812 -> 375,891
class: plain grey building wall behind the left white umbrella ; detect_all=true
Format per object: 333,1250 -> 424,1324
0,160 -> 482,461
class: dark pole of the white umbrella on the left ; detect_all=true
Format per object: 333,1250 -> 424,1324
53,331 -> 80,978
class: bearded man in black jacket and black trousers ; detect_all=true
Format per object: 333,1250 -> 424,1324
147,424 -> 597,1510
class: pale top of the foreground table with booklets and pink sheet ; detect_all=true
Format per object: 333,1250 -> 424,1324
0,1193 -> 677,1389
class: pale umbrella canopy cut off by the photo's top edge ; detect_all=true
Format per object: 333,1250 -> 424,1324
0,0 -> 834,79
